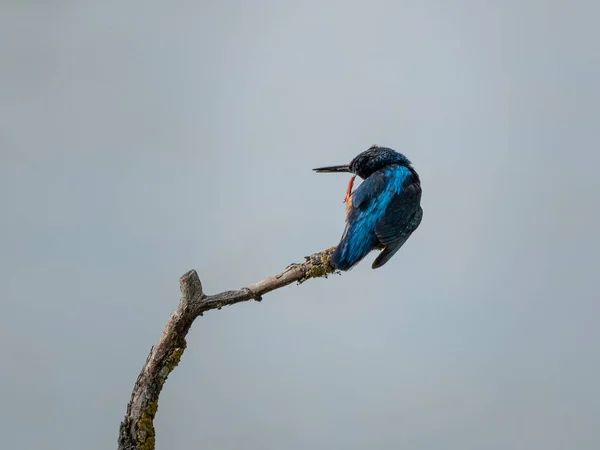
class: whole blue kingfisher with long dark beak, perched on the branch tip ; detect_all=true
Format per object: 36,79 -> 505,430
313,145 -> 423,271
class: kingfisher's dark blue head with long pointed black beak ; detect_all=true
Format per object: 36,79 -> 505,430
313,145 -> 411,180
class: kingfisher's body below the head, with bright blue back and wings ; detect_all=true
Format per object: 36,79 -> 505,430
332,165 -> 422,270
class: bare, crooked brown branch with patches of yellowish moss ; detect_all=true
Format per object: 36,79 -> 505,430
118,247 -> 335,450
